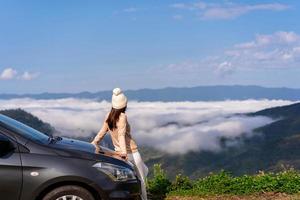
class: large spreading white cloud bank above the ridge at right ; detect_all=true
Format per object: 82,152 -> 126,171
163,31 -> 300,78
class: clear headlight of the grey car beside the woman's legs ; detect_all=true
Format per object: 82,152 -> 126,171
93,162 -> 136,181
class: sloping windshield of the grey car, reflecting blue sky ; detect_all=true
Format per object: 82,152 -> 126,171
0,114 -> 49,144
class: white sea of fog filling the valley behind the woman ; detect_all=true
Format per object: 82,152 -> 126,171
0,98 -> 294,153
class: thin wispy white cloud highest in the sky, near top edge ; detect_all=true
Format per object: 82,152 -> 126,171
171,2 -> 289,20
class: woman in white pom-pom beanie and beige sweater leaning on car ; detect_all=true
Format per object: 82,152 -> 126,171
92,88 -> 148,200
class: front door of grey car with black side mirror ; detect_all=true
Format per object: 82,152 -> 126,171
0,131 -> 22,200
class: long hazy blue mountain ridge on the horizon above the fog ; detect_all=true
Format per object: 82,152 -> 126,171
0,85 -> 300,101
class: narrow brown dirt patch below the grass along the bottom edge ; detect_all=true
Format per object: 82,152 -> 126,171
166,193 -> 300,200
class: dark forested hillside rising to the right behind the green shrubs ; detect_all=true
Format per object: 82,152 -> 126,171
144,104 -> 300,178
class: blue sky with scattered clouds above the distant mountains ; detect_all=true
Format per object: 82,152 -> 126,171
0,0 -> 300,93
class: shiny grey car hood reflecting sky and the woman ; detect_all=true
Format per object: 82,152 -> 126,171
49,138 -> 132,168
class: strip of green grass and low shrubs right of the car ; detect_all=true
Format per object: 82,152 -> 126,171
148,165 -> 300,199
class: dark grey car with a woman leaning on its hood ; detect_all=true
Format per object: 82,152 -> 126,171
0,115 -> 140,200
